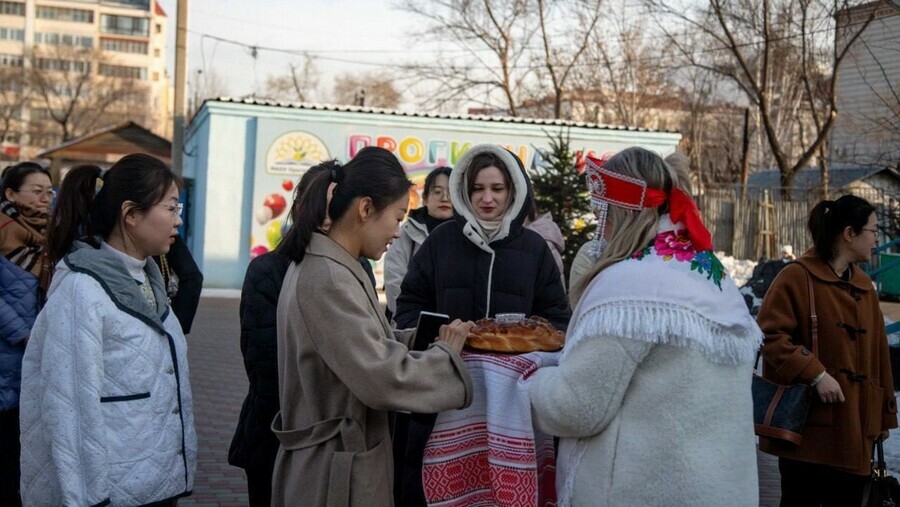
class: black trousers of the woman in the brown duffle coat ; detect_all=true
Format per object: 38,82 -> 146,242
778,458 -> 869,507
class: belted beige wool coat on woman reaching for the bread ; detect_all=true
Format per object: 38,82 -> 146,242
272,233 -> 472,507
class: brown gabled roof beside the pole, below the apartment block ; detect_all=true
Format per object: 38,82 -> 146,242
38,121 -> 172,162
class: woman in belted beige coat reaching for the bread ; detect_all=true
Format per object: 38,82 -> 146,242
272,148 -> 472,506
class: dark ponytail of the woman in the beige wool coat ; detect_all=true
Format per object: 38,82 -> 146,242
275,160 -> 338,262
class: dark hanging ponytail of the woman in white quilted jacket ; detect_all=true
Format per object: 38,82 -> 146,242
47,165 -> 101,264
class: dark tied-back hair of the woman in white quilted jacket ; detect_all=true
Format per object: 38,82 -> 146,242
49,154 -> 181,262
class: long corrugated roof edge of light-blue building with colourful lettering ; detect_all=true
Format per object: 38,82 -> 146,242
206,97 -> 678,134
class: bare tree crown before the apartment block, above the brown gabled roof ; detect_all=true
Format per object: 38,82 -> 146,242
28,45 -> 148,143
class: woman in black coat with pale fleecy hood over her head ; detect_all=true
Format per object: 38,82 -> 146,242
394,145 -> 571,505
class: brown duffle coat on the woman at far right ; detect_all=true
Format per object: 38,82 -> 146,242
758,250 -> 897,475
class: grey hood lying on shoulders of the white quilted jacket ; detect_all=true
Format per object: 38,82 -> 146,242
51,241 -> 169,333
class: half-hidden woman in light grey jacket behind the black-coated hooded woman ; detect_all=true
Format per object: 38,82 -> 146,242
384,167 -> 453,319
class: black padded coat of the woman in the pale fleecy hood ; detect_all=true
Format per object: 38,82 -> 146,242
394,217 -> 572,330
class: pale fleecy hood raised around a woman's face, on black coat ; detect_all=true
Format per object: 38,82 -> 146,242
450,144 -> 532,252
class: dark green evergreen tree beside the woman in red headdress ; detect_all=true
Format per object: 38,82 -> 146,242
530,130 -> 594,280
